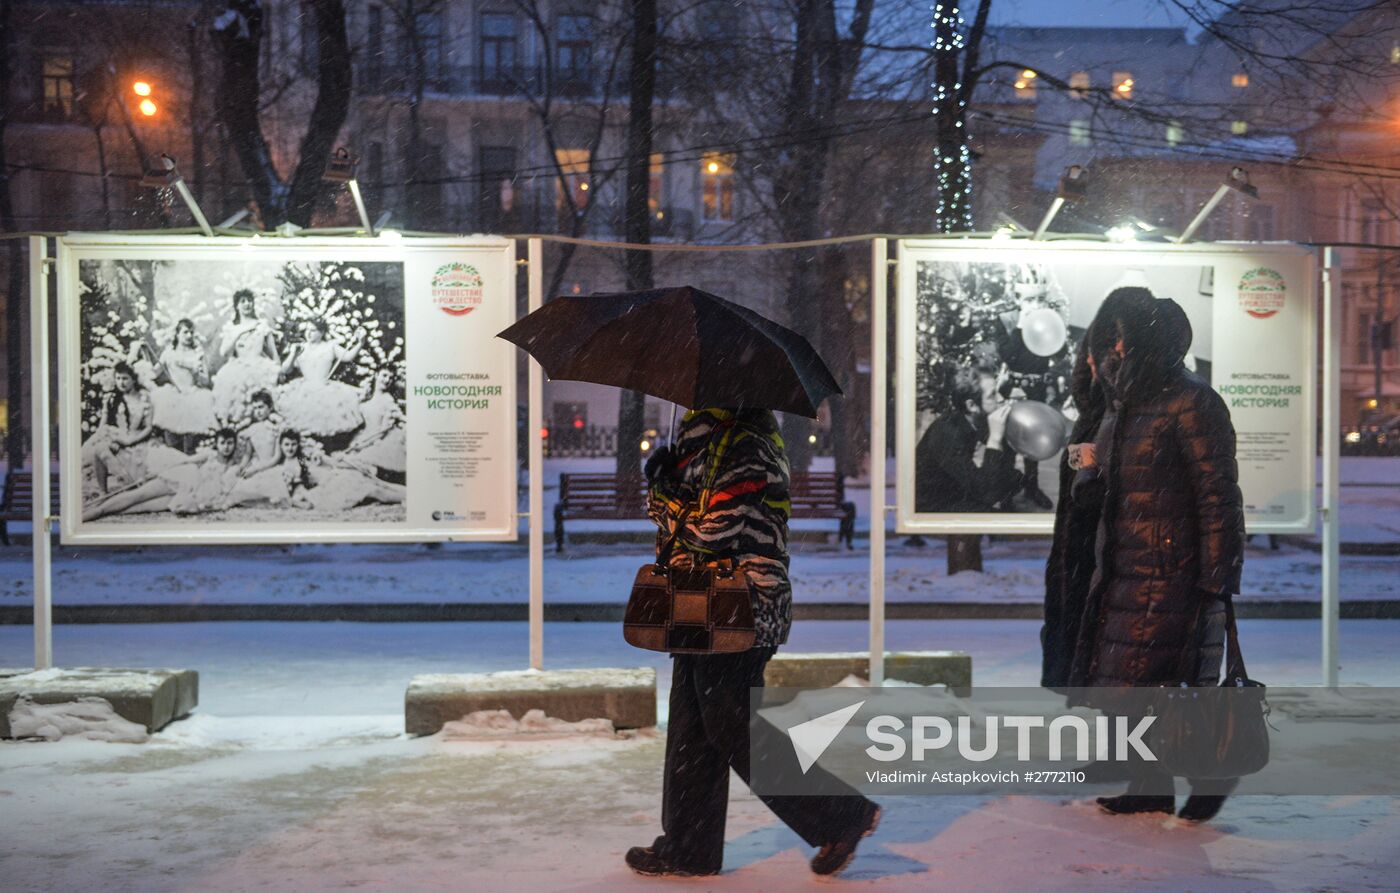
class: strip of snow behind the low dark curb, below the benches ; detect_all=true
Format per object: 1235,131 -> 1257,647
0,537 -> 1400,605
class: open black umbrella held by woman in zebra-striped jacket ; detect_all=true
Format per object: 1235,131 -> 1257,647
497,286 -> 841,419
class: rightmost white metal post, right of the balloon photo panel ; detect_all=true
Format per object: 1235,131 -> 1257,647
1322,248 -> 1341,687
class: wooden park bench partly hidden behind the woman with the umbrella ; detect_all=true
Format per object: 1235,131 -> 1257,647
554,472 -> 855,551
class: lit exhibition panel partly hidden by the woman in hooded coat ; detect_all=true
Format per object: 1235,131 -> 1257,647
896,239 -> 1317,533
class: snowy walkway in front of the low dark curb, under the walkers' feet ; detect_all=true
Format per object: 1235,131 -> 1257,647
0,620 -> 1400,893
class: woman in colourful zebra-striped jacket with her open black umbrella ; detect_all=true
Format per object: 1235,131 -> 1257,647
501,287 -> 881,876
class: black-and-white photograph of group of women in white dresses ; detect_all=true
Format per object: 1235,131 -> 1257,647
78,253 -> 407,529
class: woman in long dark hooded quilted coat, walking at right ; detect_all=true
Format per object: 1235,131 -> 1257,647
1046,290 -> 1245,820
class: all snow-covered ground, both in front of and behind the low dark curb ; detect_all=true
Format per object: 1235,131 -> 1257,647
0,460 -> 1400,893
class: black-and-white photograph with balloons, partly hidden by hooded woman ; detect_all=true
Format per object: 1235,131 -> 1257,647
914,258 -> 1212,515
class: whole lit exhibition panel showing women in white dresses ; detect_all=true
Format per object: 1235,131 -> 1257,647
57,234 -> 518,543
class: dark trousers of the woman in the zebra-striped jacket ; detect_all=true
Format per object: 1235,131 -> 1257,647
654,648 -> 875,872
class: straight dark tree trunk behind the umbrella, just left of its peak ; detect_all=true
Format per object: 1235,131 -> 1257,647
616,0 -> 657,493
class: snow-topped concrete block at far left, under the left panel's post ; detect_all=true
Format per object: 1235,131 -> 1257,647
0,666 -> 199,738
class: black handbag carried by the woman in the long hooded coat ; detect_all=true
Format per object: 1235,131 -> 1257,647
1147,596 -> 1268,778
